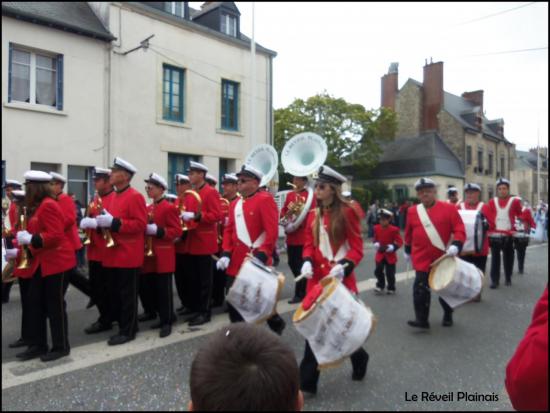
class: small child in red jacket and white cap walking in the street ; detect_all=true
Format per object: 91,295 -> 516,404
373,208 -> 403,294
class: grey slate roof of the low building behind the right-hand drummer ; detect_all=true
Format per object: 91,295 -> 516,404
373,132 -> 464,178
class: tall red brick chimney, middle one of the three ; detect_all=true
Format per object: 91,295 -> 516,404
423,58 -> 443,130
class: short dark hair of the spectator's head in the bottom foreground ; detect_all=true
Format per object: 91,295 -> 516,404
189,322 -> 299,411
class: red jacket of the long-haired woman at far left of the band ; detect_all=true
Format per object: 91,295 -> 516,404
27,197 -> 76,277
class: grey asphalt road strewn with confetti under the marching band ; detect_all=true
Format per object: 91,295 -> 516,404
2,238 -> 548,410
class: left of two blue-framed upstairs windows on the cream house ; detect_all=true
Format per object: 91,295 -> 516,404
162,65 -> 185,123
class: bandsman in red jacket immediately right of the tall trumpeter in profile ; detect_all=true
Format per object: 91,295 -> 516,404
139,173 -> 183,338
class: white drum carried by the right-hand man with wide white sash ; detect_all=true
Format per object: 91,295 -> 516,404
428,256 -> 483,308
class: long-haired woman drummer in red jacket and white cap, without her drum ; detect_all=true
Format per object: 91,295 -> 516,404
300,166 -> 369,394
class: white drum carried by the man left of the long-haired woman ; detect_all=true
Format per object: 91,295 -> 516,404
227,257 -> 285,323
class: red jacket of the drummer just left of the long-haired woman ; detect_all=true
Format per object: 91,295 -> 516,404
223,191 -> 279,277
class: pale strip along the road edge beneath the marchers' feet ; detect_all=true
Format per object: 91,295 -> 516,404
2,244 -> 548,390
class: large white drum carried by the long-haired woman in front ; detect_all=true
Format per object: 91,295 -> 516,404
292,277 -> 375,368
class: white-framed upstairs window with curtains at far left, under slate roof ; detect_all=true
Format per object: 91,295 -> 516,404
8,43 -> 63,110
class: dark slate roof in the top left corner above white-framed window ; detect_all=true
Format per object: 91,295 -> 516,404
2,1 -> 116,42
